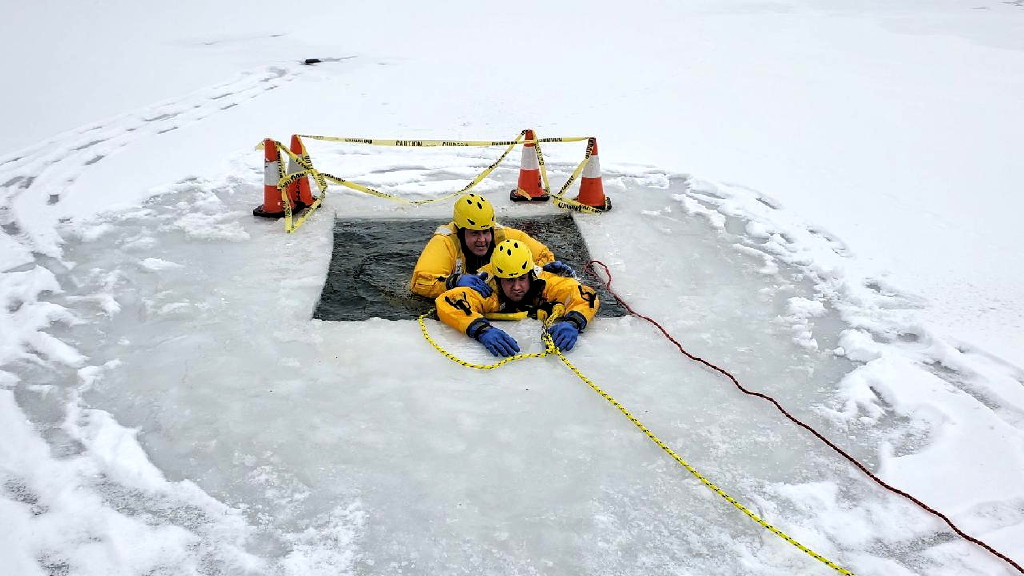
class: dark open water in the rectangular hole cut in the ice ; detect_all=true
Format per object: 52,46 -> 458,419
313,214 -> 626,322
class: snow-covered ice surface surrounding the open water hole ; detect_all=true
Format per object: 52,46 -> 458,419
0,1 -> 1024,576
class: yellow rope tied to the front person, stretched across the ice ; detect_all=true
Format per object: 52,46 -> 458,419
419,310 -> 855,576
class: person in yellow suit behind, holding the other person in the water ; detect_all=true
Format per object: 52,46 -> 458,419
409,194 -> 573,298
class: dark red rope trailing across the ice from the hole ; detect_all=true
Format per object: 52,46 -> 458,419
584,260 -> 1024,574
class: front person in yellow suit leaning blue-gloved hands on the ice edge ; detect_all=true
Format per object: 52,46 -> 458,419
434,240 -> 601,357
